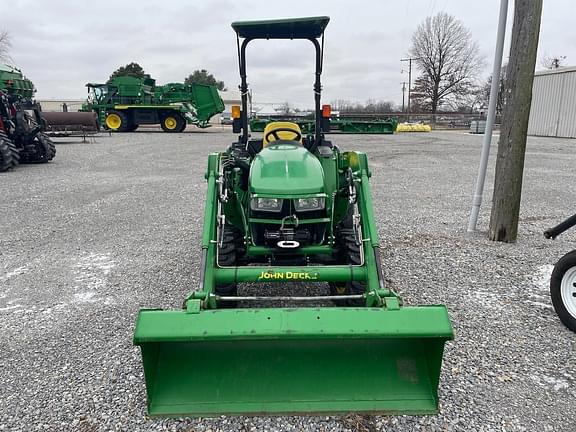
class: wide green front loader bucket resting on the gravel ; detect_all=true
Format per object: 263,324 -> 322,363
134,306 -> 452,416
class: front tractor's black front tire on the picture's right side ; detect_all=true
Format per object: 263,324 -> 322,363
329,205 -> 366,306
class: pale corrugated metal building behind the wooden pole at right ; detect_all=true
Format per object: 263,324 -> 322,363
528,67 -> 576,138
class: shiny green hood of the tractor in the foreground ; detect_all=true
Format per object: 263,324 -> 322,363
250,143 -> 324,196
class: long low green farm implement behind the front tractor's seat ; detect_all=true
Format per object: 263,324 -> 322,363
249,115 -> 398,134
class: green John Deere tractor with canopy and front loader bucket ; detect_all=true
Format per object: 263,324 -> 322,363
134,17 -> 453,416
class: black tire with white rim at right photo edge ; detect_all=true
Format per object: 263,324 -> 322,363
550,250 -> 576,333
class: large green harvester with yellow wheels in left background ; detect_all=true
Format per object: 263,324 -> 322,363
82,76 -> 224,132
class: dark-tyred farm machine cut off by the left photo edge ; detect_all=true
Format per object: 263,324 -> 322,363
0,66 -> 56,171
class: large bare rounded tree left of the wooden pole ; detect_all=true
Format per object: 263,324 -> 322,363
410,12 -> 484,114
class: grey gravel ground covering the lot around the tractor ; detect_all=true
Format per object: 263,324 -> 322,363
0,128 -> 576,432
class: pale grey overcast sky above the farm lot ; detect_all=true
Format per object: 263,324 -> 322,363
0,0 -> 576,106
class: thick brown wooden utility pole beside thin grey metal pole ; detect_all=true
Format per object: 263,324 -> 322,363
488,0 -> 542,242
